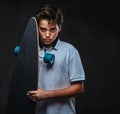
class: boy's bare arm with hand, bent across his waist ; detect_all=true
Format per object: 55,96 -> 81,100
27,82 -> 84,101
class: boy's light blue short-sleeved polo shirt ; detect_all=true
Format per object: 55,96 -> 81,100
36,39 -> 85,114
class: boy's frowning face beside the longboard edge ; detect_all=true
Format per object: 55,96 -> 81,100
38,20 -> 61,47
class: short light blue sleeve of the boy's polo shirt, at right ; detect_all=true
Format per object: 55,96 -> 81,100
69,48 -> 85,82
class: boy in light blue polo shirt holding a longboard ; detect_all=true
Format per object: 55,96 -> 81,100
27,5 -> 85,114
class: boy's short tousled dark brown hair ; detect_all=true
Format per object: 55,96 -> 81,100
35,4 -> 63,27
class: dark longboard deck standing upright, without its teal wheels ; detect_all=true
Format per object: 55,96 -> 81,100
6,17 -> 39,114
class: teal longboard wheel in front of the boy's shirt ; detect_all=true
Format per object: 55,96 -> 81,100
43,53 -> 55,65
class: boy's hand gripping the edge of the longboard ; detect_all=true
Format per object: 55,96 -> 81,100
26,88 -> 46,102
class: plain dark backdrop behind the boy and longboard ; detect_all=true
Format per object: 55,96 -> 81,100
0,0 -> 120,114
